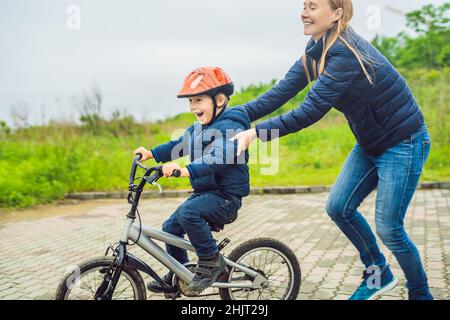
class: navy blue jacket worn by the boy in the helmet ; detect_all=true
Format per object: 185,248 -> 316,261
152,106 -> 250,197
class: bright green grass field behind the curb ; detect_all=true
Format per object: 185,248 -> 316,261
0,69 -> 450,208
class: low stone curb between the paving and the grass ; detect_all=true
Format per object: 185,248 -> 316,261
65,182 -> 450,200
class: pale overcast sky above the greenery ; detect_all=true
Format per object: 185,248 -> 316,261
0,0 -> 448,124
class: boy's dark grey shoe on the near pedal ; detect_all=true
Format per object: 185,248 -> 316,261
188,253 -> 227,292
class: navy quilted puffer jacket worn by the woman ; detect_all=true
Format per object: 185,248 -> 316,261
244,28 -> 424,156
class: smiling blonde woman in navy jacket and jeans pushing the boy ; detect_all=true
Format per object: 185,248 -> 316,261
234,0 -> 433,300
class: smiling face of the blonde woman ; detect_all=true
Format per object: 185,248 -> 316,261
301,0 -> 342,41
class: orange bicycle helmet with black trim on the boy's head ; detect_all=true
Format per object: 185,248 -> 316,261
177,67 -> 234,122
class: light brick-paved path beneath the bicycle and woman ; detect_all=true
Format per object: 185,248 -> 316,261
0,190 -> 450,299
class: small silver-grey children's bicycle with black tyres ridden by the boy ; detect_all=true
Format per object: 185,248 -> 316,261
56,154 -> 301,300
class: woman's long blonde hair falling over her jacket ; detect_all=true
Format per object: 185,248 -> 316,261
302,0 -> 373,85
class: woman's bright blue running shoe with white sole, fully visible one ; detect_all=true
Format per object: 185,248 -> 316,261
348,265 -> 398,300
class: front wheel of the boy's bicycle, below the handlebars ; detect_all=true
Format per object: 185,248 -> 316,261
55,256 -> 147,300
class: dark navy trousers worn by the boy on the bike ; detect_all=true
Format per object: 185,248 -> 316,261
163,192 -> 242,264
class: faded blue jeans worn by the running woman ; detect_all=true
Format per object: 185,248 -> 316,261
327,125 -> 431,295
